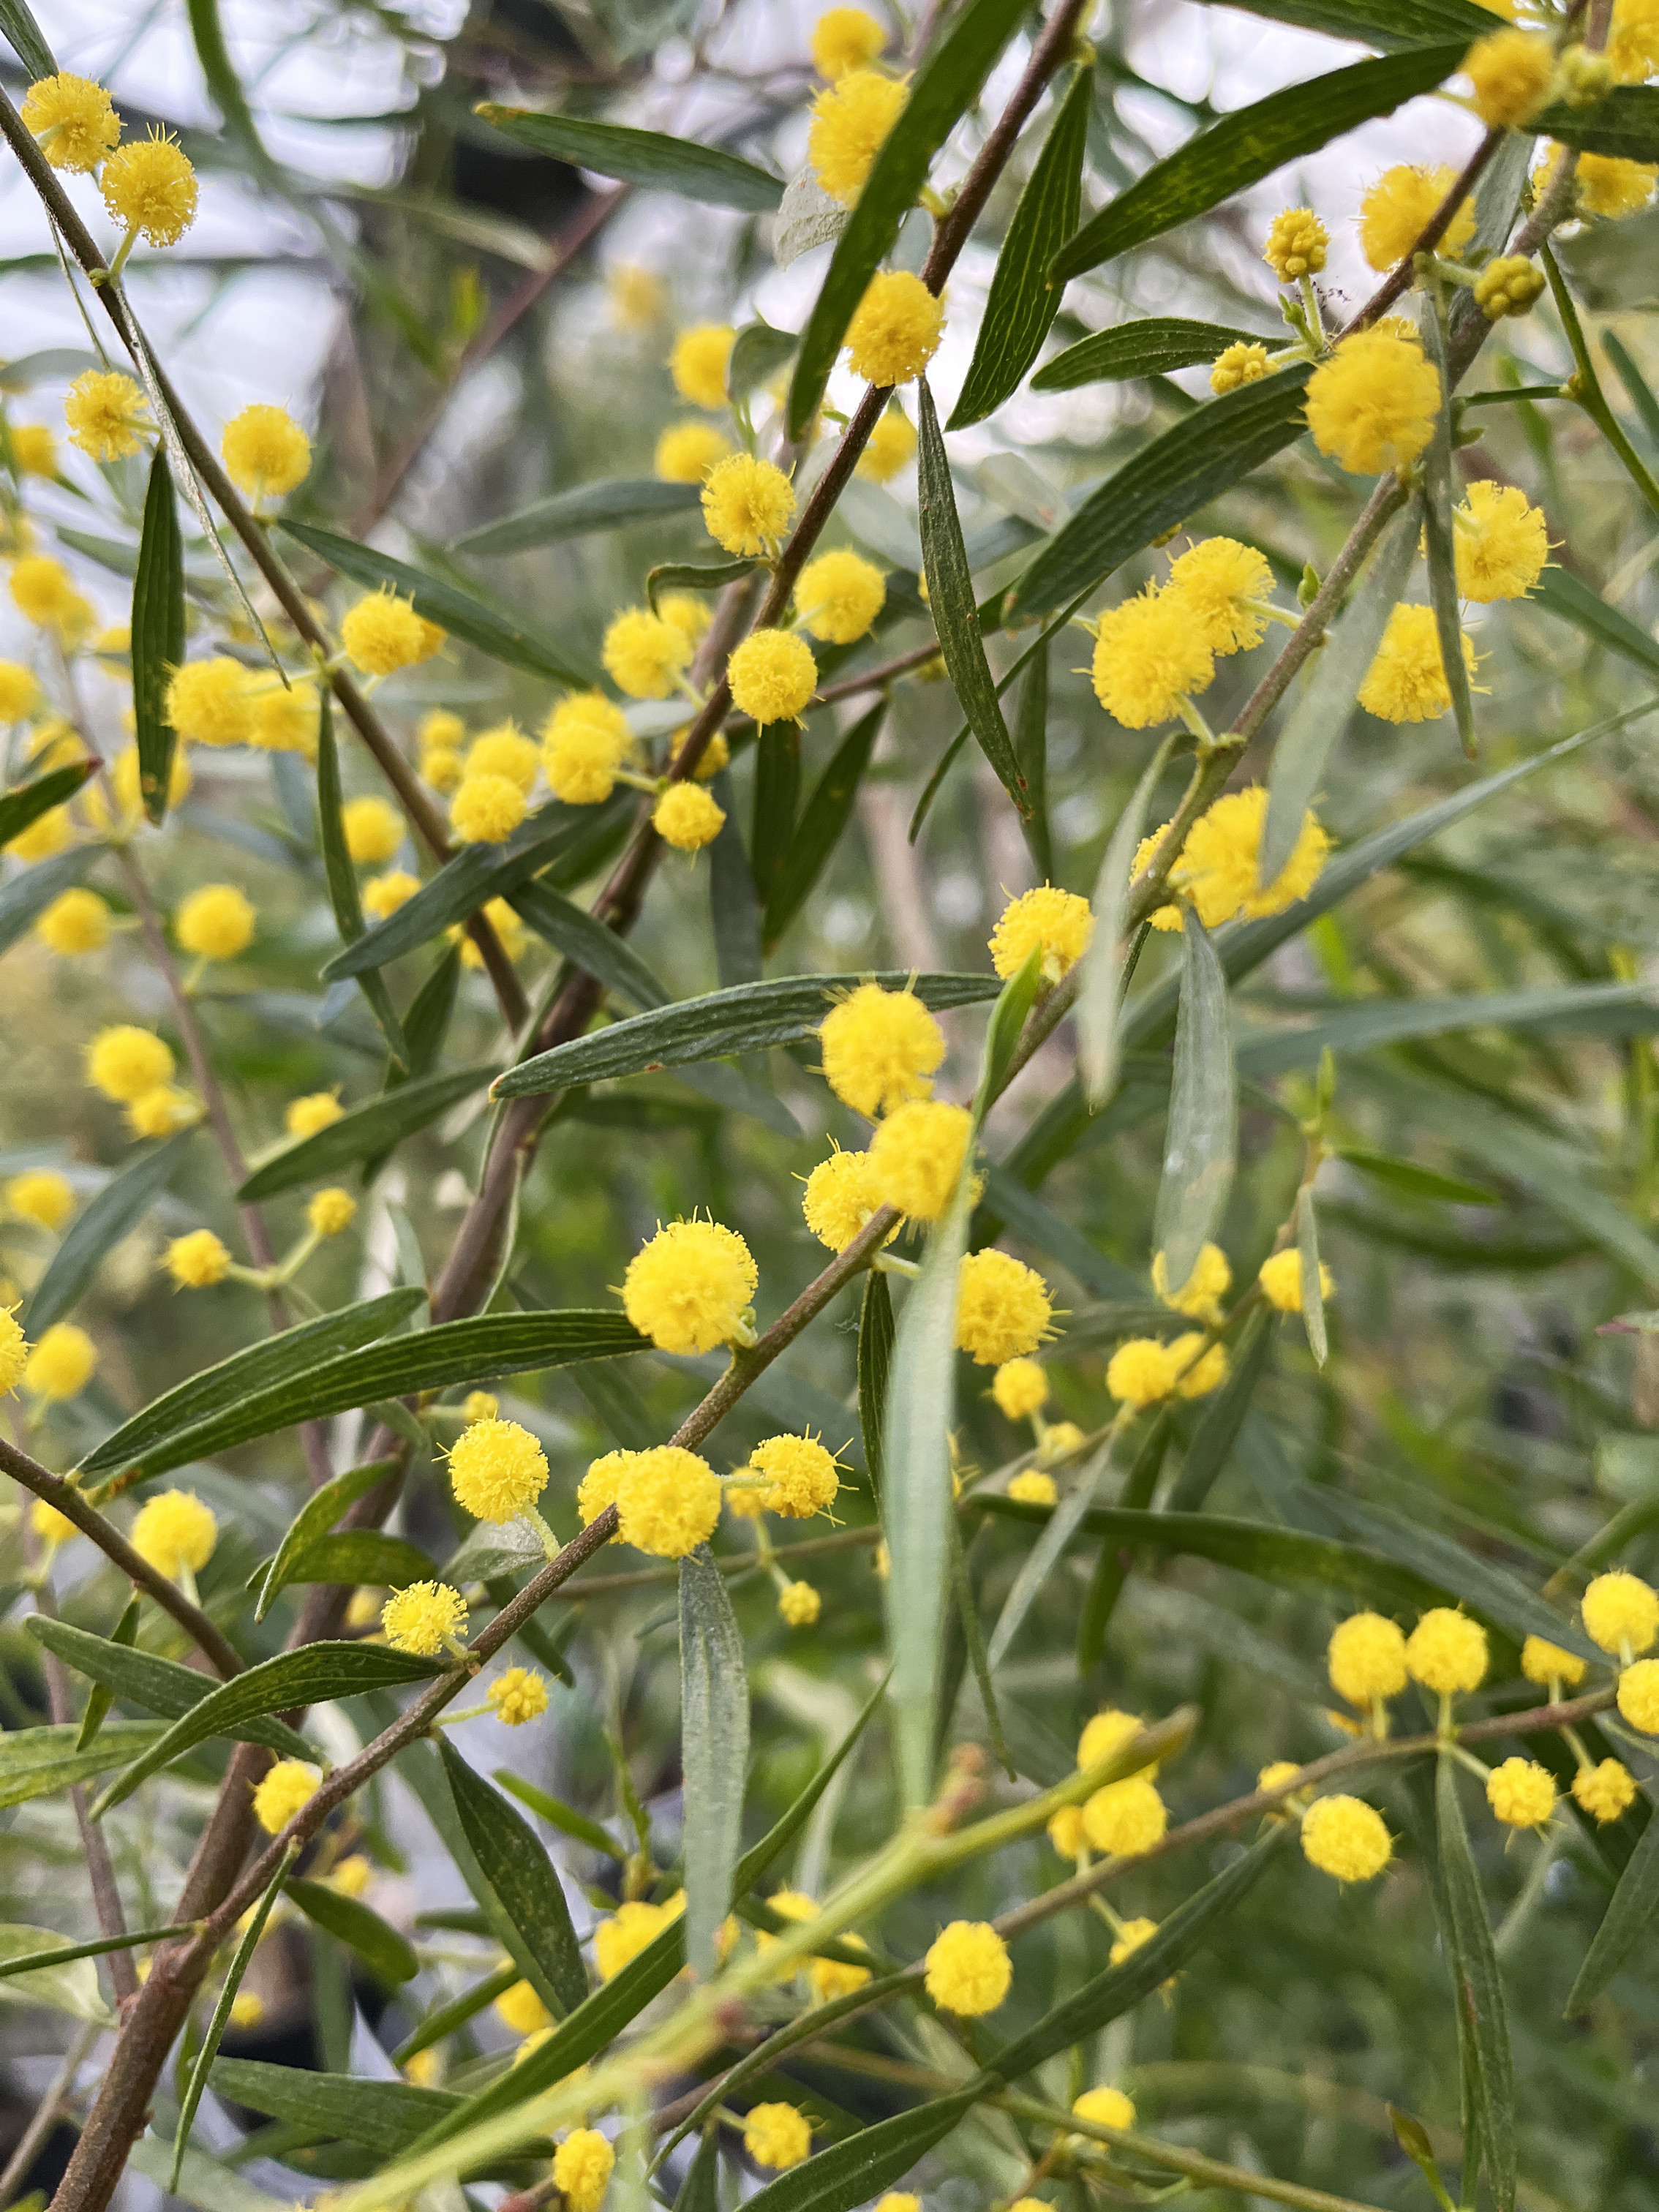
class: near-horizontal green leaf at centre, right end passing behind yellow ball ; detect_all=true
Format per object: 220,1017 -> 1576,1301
493,969 -> 1002,1099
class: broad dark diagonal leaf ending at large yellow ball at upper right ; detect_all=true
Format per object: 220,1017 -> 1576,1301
1002,365 -> 1312,622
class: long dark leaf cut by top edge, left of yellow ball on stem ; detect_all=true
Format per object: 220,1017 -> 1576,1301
790,0 -> 1024,438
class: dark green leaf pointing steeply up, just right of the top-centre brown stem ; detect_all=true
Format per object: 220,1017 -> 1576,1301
949,62 -> 1095,429
